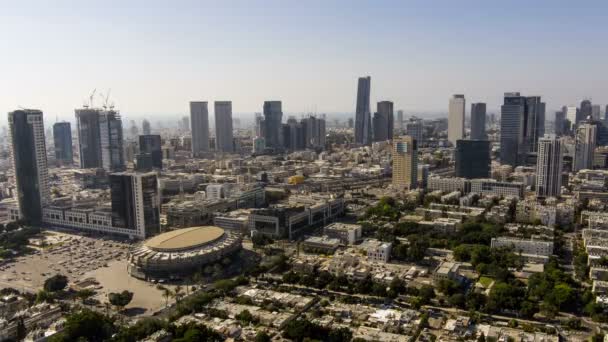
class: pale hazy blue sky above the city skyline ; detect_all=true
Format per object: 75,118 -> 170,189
0,0 -> 608,120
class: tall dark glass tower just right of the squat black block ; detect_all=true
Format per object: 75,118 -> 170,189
500,92 -> 526,167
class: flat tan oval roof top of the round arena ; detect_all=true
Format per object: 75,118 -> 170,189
145,226 -> 224,252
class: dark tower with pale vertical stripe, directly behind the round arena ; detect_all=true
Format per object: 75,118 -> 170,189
110,172 -> 160,238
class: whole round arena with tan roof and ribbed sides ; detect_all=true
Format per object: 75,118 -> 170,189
127,226 -> 241,280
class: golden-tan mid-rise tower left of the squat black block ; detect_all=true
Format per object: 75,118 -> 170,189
393,135 -> 418,189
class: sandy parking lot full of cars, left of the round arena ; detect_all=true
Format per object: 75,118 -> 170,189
0,231 -> 129,292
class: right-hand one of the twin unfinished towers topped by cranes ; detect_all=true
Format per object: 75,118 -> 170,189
99,110 -> 126,172
